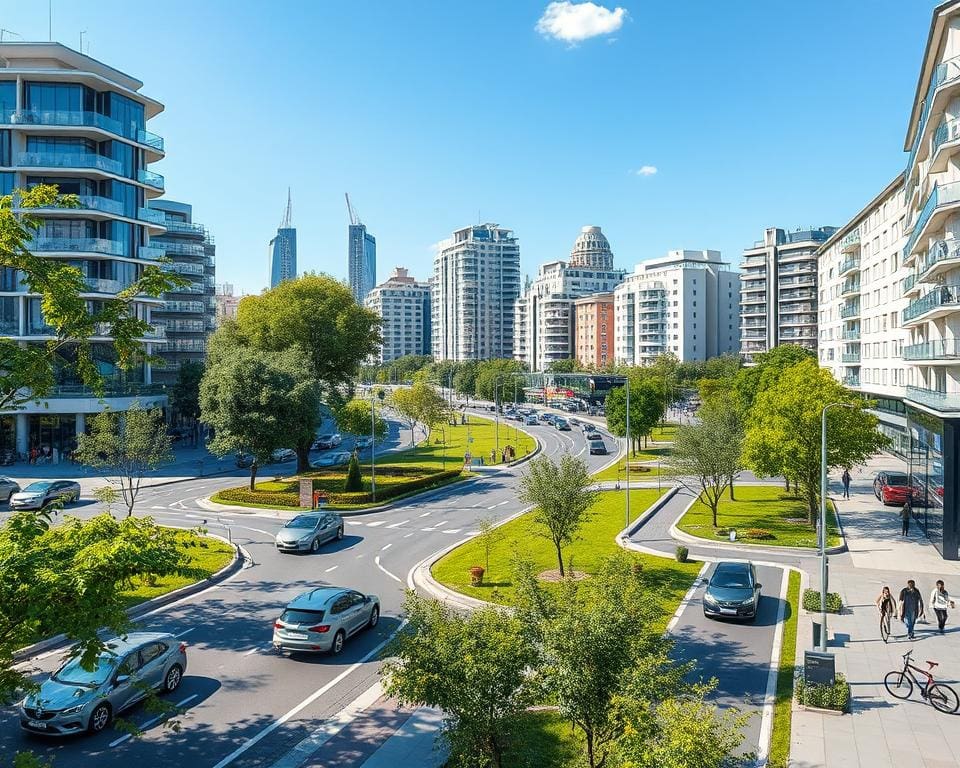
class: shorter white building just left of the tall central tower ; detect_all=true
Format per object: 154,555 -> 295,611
364,267 -> 430,363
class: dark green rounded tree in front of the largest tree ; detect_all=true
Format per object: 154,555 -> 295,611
200,344 -> 320,490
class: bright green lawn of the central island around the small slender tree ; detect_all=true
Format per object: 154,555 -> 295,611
432,489 -> 700,626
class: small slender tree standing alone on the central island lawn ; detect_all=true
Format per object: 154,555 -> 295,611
517,454 -> 597,576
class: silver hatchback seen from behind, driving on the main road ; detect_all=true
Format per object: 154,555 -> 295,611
273,587 -> 380,654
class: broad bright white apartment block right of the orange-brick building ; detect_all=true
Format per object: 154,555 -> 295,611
613,251 -> 740,365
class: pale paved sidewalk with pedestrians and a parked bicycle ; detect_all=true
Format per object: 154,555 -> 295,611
790,456 -> 960,768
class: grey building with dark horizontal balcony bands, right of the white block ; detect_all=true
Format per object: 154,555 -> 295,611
740,227 -> 836,363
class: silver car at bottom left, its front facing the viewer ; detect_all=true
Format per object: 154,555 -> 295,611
19,632 -> 187,736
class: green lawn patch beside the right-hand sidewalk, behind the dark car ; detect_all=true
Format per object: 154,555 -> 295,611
677,485 -> 841,547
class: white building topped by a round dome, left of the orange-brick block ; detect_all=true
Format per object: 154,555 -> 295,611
513,226 -> 624,371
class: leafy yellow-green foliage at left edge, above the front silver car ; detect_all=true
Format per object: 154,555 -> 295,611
0,512 -> 186,701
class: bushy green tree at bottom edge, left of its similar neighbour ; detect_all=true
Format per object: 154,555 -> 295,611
383,592 -> 536,768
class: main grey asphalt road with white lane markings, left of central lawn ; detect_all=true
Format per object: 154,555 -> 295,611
0,414 -> 612,768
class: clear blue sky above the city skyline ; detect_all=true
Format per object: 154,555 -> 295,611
0,0 -> 935,292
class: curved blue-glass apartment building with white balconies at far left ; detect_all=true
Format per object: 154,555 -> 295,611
0,42 -> 166,461
